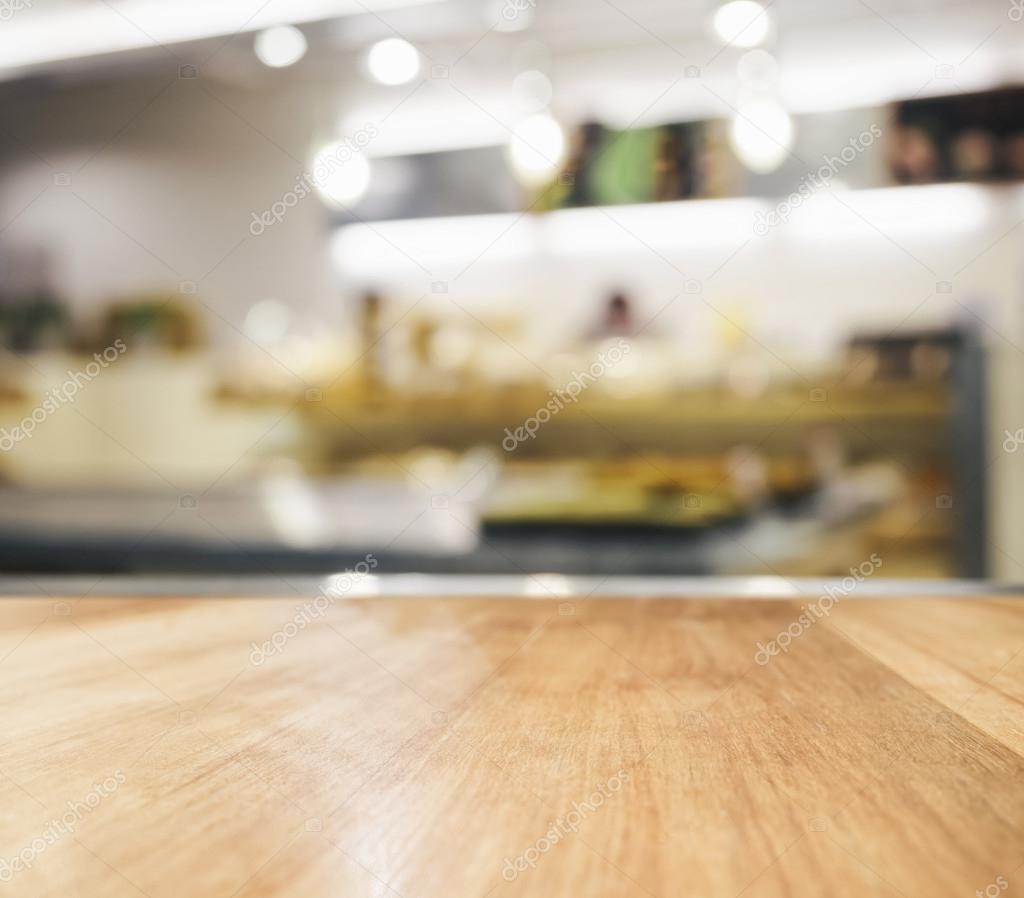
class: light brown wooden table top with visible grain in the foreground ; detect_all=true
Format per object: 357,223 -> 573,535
0,598 -> 1024,898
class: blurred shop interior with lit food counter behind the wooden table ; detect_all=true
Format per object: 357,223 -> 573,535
0,0 -> 1024,581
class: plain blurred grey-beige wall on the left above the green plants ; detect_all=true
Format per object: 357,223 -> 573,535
0,70 -> 340,342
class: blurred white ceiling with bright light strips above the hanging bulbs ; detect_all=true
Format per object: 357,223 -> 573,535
0,0 -> 1024,123
